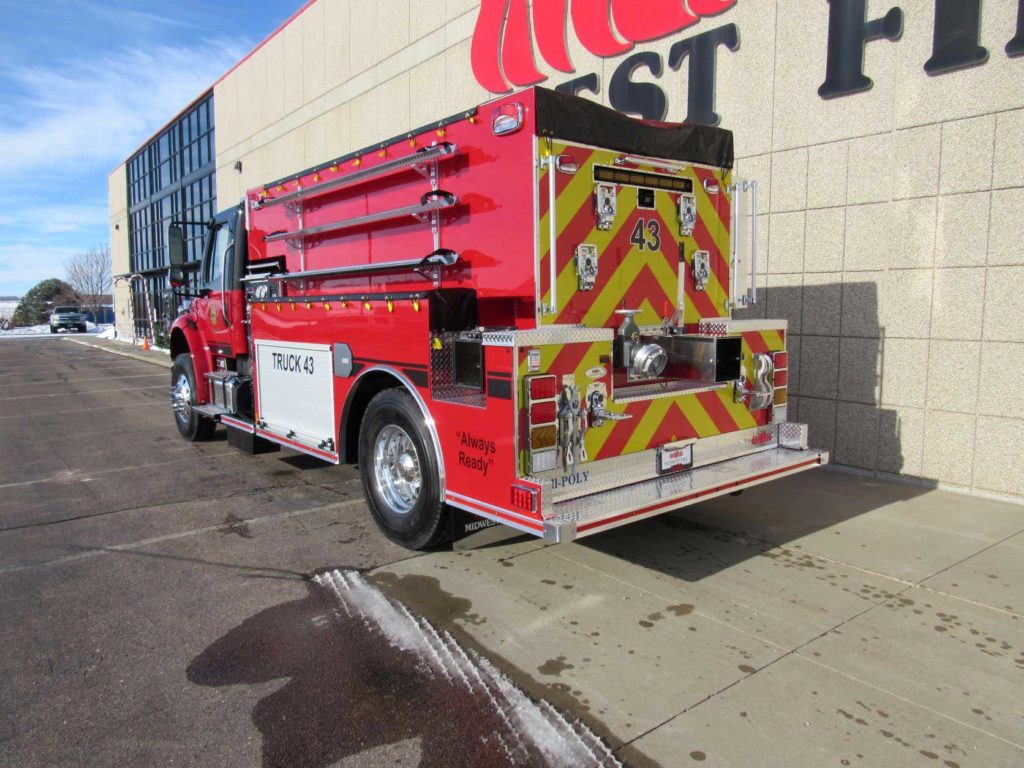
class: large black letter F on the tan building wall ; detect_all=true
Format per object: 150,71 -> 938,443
818,0 -> 903,98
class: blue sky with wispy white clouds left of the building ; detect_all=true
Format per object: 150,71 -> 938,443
0,0 -> 304,296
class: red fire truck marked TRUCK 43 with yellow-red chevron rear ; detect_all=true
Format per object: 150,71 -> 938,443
163,88 -> 828,549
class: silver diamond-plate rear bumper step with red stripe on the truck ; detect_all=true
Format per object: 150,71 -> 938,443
544,447 -> 828,543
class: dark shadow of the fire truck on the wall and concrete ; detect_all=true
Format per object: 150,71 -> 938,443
584,275 -> 934,581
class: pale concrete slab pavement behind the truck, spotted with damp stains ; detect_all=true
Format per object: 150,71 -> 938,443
370,471 -> 1024,768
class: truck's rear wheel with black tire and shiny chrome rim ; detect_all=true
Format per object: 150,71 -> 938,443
358,389 -> 452,550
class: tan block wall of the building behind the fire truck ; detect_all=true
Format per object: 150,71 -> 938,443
114,0 -> 1024,499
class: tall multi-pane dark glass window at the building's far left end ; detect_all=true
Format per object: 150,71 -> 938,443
126,91 -> 217,335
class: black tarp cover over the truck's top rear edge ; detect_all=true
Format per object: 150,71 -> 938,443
534,88 -> 733,168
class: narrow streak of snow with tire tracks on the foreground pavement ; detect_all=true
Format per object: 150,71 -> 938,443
315,570 -> 622,768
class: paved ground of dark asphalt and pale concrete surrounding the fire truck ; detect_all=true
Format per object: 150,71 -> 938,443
0,338 -> 1024,768
